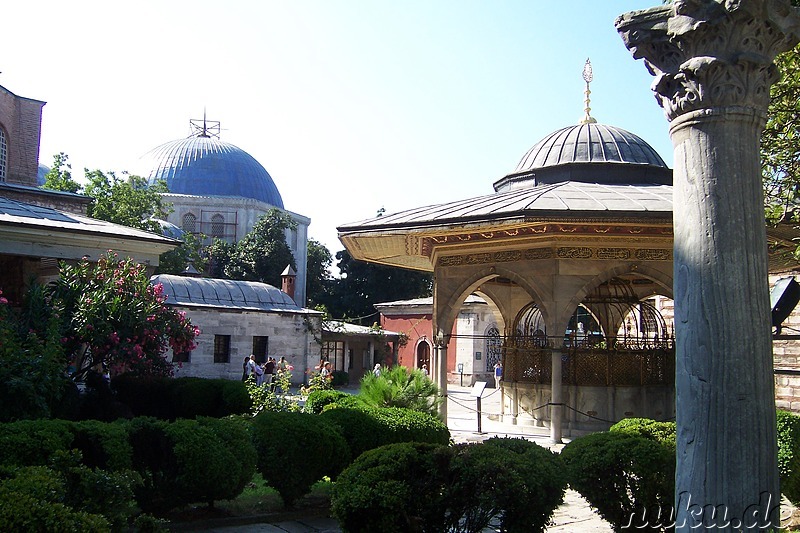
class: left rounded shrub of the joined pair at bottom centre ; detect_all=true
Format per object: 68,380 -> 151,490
331,442 -> 450,533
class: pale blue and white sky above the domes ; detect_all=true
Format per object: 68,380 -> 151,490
0,0 -> 672,260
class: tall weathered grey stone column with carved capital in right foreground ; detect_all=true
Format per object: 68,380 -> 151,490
616,0 -> 800,531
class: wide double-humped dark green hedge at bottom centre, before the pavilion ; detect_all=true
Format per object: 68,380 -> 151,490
331,439 -> 566,533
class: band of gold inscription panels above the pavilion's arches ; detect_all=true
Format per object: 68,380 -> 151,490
437,246 -> 672,267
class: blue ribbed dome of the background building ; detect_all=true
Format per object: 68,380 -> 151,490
140,134 -> 283,209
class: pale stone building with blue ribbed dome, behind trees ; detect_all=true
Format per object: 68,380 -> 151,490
137,118 -> 311,307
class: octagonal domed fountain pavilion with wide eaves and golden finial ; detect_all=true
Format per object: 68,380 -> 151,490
338,68 -> 675,442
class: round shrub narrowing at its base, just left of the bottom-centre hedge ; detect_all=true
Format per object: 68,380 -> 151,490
252,411 -> 350,507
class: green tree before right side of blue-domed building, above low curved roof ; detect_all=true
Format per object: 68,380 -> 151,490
225,208 -> 297,287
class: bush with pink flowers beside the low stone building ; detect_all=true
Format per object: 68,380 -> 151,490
53,251 -> 200,376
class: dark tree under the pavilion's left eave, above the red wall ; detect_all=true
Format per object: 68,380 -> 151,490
329,250 -> 433,324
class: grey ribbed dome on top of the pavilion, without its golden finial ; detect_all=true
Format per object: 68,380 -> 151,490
494,122 -> 672,191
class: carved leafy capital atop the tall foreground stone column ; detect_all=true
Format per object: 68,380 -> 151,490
615,0 -> 800,121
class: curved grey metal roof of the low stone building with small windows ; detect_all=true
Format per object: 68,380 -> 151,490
150,274 -> 322,315
